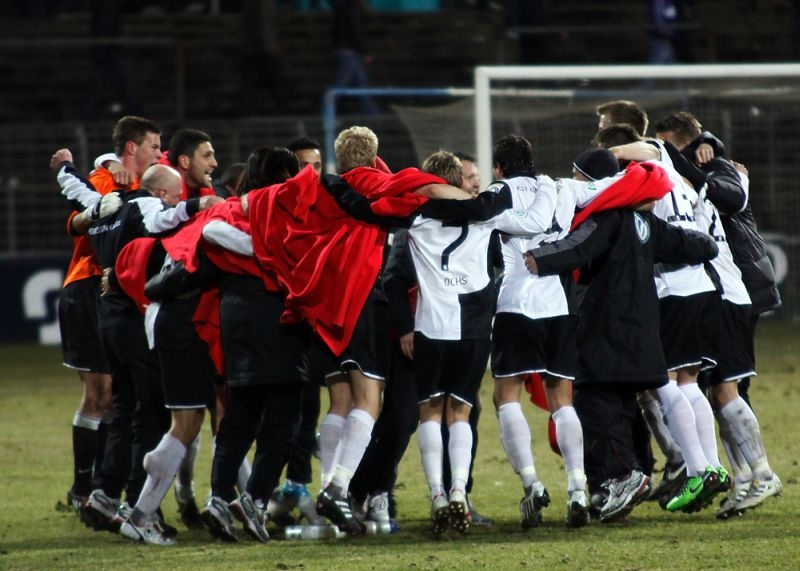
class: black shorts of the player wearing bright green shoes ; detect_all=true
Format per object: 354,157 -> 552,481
659,291 -> 722,371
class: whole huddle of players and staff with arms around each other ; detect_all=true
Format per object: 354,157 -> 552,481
51,101 -> 781,545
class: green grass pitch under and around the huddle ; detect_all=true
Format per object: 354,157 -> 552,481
0,321 -> 800,571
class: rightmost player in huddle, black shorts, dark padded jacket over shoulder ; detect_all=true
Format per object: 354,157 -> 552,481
656,111 -> 782,519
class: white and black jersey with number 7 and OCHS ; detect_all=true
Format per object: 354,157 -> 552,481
408,177 -> 556,340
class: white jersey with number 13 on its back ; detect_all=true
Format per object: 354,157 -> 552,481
653,141 -> 716,298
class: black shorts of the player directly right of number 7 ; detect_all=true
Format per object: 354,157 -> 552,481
492,313 -> 578,380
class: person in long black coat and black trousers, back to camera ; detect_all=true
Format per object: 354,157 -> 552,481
525,177 -> 717,522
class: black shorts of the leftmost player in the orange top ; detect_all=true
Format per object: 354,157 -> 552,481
58,276 -> 111,373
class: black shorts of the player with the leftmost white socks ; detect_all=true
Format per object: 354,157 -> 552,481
155,296 -> 219,409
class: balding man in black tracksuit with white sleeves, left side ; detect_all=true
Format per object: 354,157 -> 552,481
58,156 -> 221,543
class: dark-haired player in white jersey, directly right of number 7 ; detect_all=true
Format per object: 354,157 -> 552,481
492,145 -> 619,529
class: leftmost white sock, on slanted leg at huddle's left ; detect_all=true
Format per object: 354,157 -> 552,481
134,434 -> 186,524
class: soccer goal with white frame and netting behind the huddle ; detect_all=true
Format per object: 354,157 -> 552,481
394,64 -> 800,318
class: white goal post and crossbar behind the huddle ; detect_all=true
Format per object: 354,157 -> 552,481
474,63 -> 800,190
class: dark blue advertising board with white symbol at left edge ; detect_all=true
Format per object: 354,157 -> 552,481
0,254 -> 70,344
